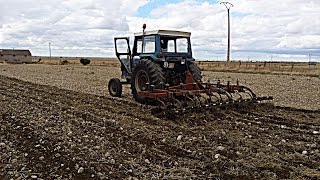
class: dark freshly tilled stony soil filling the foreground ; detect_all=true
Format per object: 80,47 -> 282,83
0,66 -> 320,179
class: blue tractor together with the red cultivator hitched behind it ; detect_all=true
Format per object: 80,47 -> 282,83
108,24 -> 272,112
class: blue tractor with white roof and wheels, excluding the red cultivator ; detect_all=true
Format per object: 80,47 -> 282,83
112,24 -> 202,103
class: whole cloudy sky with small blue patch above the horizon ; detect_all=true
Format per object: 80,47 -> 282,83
0,0 -> 320,62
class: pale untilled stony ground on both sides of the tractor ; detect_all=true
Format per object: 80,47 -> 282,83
0,64 -> 320,110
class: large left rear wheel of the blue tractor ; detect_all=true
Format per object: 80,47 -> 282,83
131,59 -> 165,103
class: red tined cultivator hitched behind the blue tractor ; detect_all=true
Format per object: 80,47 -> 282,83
139,72 -> 273,114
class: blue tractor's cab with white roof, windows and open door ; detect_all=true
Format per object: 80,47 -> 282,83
115,30 -> 194,80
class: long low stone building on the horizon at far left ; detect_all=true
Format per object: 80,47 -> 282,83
0,49 -> 32,63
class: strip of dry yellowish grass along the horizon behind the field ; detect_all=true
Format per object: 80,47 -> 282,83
32,57 -> 320,77
